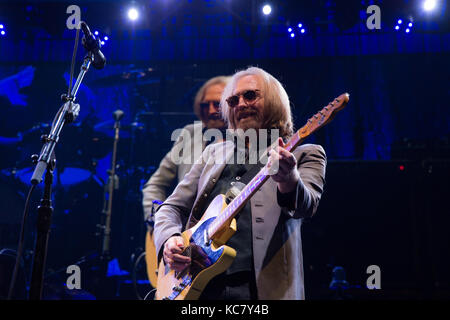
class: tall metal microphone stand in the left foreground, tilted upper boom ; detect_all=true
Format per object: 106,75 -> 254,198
29,52 -> 94,300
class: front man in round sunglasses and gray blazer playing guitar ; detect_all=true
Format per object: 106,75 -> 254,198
155,67 -> 326,300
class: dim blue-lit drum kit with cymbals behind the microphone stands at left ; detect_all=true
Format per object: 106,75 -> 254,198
0,68 -> 200,298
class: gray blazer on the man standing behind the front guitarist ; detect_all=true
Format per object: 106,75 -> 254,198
142,121 -> 205,220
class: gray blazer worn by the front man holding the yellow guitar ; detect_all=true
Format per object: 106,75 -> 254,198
154,141 -> 326,300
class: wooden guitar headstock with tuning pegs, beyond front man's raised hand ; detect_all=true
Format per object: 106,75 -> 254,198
298,93 -> 350,139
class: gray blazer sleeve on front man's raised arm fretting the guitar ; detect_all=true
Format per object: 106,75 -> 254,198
277,144 -> 327,218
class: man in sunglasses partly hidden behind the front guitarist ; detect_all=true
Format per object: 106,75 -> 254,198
142,76 -> 230,222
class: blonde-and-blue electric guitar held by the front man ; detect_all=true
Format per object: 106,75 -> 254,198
155,93 -> 350,300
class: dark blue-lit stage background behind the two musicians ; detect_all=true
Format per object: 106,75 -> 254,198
0,0 -> 450,299
